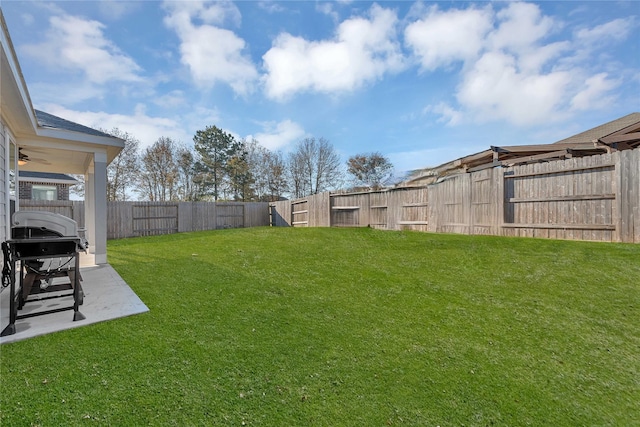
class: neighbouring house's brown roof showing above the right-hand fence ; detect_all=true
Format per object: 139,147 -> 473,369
399,113 -> 640,186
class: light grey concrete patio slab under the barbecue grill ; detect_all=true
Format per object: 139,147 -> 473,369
0,254 -> 149,344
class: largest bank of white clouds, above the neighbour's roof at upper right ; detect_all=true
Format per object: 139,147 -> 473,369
405,2 -> 635,126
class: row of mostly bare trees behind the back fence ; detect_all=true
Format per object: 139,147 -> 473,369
103,126 -> 393,201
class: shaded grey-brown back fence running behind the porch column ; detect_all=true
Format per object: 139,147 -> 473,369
20,200 -> 269,239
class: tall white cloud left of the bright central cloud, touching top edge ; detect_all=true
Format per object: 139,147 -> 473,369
165,1 -> 258,95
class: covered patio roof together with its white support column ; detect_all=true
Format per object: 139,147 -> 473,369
0,10 -> 124,264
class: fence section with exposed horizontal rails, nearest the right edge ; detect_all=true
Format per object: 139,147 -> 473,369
502,155 -> 619,241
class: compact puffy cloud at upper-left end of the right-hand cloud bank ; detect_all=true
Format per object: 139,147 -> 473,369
404,6 -> 492,71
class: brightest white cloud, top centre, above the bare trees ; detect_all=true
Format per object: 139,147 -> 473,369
262,5 -> 404,100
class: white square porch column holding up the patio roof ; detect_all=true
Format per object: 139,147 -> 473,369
84,153 -> 107,264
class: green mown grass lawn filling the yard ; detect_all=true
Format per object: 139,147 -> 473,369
0,228 -> 640,426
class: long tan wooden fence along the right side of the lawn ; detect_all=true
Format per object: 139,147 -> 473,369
269,149 -> 640,243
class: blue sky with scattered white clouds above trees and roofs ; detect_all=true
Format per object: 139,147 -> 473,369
2,0 -> 640,171
